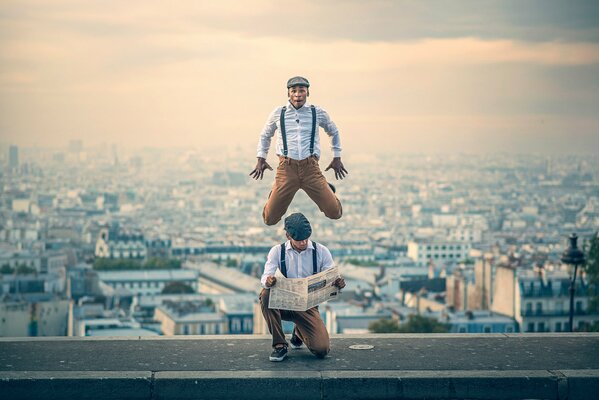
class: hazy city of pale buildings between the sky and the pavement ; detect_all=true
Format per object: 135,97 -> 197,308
0,140 -> 599,336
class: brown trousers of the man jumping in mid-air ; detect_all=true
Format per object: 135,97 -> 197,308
262,156 -> 342,225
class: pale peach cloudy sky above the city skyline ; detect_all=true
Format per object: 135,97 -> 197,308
0,0 -> 599,157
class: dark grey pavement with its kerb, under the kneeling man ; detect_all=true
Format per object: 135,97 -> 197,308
0,333 -> 599,399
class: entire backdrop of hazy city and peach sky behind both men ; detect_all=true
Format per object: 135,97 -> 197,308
0,0 -> 599,336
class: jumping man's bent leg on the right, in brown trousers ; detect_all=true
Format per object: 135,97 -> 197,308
301,158 -> 343,219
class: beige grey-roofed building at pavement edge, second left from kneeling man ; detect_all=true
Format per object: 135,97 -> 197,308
154,300 -> 227,336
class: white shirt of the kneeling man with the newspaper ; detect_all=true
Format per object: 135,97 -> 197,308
260,240 -> 334,288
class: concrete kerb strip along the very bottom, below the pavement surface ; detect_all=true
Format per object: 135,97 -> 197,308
0,370 -> 599,400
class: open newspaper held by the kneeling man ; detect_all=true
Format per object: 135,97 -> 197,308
268,267 -> 340,311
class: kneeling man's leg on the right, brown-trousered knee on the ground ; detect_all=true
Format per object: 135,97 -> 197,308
292,307 -> 331,358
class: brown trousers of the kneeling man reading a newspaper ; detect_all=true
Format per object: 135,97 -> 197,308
260,289 -> 330,358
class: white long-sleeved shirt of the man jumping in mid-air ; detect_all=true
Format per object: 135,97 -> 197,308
258,102 -> 341,160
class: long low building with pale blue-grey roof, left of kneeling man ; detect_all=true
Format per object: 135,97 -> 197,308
98,269 -> 199,296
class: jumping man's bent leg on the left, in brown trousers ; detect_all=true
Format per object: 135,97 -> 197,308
262,159 -> 300,225
